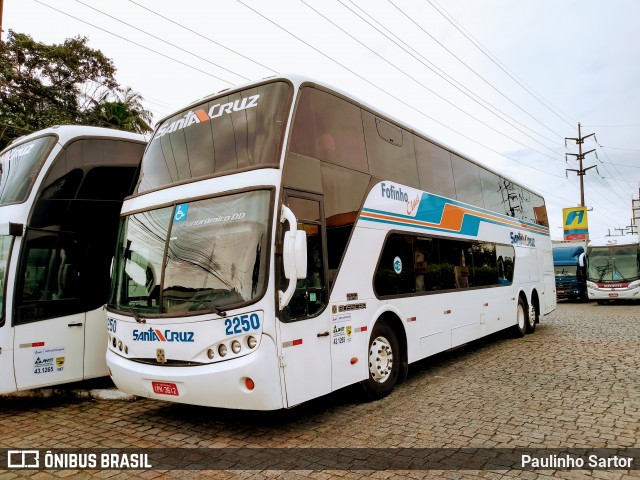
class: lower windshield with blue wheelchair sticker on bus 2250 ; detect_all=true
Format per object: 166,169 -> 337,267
110,190 -> 272,315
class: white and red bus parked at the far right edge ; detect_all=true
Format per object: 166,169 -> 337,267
587,235 -> 640,305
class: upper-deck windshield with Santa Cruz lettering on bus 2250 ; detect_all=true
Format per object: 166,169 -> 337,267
137,82 -> 291,193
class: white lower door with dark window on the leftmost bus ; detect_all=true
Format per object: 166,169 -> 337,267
13,230 -> 85,389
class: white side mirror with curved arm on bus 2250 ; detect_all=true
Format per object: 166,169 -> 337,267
278,205 -> 307,309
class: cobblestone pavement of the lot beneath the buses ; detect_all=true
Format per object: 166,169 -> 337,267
0,302 -> 640,480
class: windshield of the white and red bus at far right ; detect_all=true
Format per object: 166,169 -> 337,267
589,245 -> 640,282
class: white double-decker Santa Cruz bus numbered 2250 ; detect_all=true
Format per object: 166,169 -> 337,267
107,76 -> 555,410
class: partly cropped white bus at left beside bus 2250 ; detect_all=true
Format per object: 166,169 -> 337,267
0,126 -> 146,393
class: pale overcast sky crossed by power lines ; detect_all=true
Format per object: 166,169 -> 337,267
2,0 -> 640,239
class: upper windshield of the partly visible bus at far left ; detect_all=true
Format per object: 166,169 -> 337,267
0,135 -> 56,205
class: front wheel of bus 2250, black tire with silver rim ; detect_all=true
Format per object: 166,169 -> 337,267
362,322 -> 402,400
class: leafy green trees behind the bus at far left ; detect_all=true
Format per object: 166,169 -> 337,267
0,30 -> 151,149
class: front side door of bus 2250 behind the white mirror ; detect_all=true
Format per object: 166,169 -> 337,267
280,191 -> 331,407
